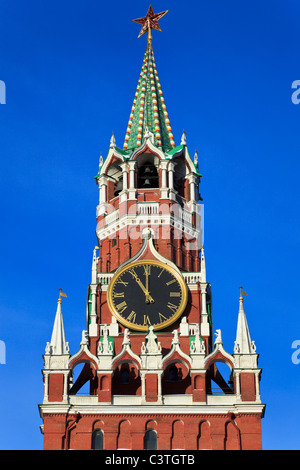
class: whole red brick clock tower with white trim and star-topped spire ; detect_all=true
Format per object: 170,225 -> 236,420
39,7 -> 264,450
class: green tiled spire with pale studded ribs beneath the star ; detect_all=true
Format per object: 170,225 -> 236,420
124,41 -> 175,151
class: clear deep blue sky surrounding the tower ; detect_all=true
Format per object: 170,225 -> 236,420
0,0 -> 300,449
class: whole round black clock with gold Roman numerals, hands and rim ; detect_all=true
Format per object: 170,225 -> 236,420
107,261 -> 187,331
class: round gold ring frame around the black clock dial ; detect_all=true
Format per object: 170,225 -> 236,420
107,260 -> 188,331
